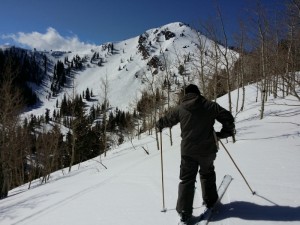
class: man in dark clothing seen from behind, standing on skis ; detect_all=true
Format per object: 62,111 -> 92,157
156,84 -> 235,224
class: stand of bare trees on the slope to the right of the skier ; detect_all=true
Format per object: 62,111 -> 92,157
191,0 -> 300,119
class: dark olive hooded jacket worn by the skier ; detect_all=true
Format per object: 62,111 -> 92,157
157,93 -> 235,156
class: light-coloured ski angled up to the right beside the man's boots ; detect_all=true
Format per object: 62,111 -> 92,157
195,175 -> 233,225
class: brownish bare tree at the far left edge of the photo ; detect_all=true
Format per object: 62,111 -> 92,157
0,62 -> 24,198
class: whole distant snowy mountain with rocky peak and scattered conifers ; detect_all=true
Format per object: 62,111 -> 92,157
1,22 -> 235,118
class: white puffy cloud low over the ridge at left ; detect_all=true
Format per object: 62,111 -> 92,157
2,27 -> 95,51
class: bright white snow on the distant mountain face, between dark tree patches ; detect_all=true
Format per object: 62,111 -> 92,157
22,22 -> 235,118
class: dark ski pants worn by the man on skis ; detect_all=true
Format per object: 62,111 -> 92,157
176,153 -> 218,214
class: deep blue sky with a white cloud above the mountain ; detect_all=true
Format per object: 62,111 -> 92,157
0,0 -> 280,49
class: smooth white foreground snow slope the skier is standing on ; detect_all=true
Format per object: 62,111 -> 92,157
0,86 -> 300,225
